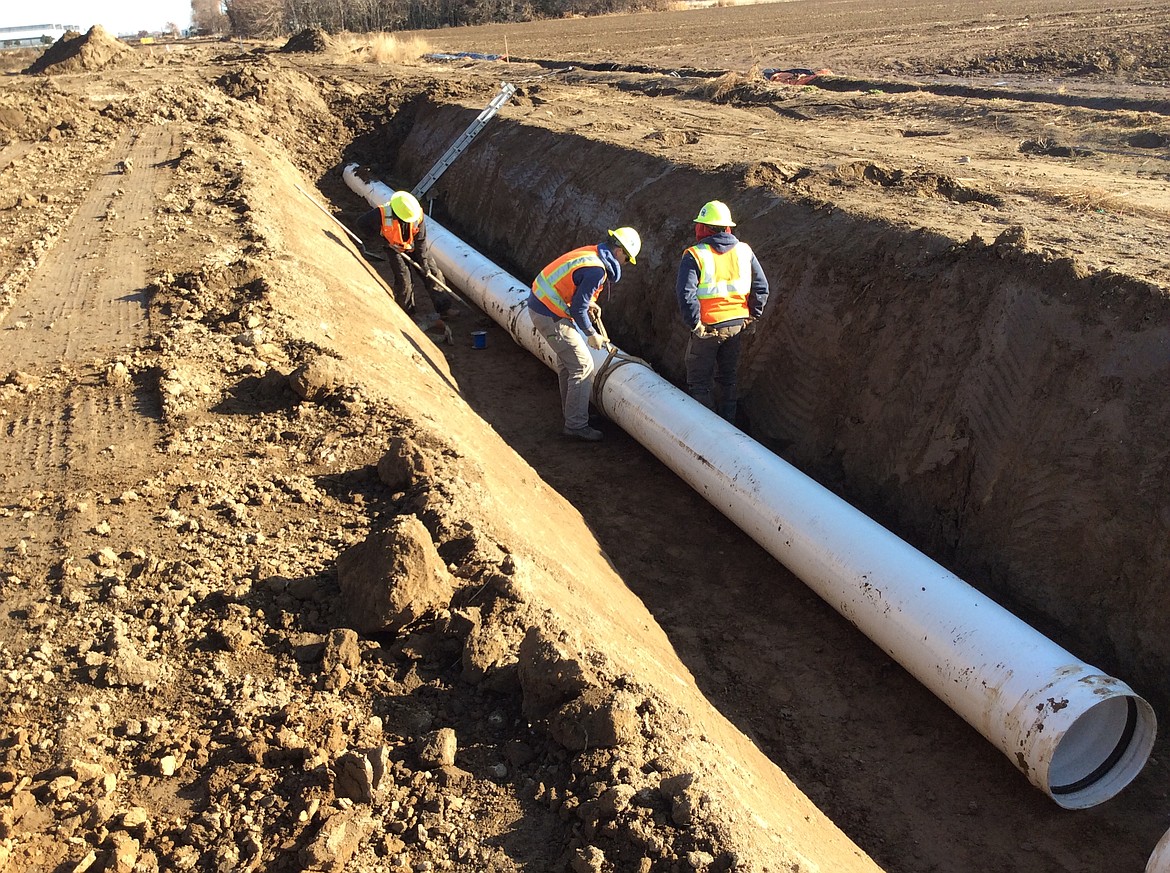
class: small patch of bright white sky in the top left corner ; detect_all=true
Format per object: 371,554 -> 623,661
0,0 -> 191,35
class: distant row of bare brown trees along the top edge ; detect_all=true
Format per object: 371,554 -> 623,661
191,0 -> 670,39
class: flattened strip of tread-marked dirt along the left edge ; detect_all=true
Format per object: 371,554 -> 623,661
0,126 -> 177,495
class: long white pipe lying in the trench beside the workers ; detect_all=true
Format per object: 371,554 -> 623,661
344,165 -> 1157,809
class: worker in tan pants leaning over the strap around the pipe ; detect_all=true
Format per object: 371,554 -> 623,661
528,227 -> 642,442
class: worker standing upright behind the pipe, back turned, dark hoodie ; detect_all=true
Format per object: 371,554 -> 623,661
675,200 -> 769,424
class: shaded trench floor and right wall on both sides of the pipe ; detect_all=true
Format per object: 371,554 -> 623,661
306,84 -> 1170,871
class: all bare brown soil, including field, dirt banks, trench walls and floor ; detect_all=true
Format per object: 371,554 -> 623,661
0,0 -> 1170,873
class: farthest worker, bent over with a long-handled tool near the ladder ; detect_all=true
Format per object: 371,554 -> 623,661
357,191 -> 452,316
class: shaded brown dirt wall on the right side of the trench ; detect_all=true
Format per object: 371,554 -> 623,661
383,101 -> 1170,707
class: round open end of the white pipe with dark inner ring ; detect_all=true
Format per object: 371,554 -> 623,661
1044,692 -> 1157,810
